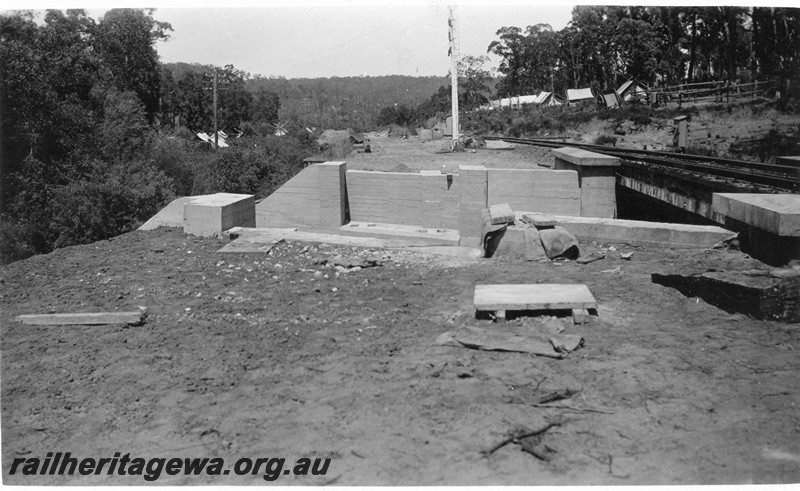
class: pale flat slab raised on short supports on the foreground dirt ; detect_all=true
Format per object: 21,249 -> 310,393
474,283 -> 597,311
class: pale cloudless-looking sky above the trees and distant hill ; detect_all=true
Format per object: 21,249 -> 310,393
20,0 -> 572,78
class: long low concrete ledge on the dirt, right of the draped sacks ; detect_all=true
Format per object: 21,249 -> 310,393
517,212 -> 737,248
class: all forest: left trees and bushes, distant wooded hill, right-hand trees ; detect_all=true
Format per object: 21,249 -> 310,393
0,6 -> 800,261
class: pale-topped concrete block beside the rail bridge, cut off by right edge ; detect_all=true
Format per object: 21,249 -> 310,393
711,193 -> 800,237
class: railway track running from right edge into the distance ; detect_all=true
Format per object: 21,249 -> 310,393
483,136 -> 800,192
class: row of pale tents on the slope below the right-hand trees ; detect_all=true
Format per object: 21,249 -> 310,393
481,79 -> 649,111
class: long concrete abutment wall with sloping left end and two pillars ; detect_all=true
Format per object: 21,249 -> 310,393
256,162 -> 581,243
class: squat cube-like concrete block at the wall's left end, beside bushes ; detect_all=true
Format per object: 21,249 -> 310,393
183,193 -> 256,236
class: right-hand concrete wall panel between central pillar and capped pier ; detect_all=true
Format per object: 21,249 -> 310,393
487,169 -> 581,216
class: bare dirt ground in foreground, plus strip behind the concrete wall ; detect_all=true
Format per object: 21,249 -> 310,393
0,135 -> 800,485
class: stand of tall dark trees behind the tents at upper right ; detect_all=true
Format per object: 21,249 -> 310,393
488,5 -> 800,97
